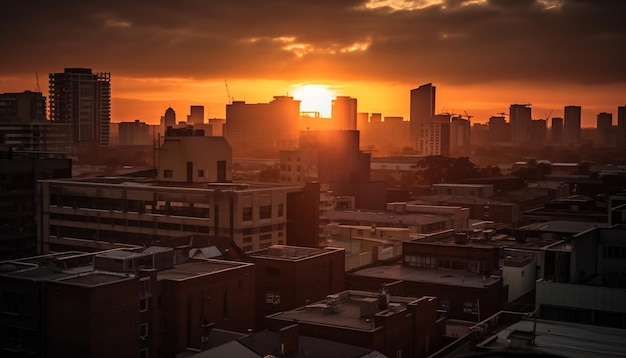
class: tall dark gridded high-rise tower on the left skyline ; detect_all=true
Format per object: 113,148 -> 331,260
49,68 -> 111,146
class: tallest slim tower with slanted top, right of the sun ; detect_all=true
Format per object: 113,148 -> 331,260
409,83 -> 436,154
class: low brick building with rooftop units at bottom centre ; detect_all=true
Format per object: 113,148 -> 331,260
266,290 -> 442,357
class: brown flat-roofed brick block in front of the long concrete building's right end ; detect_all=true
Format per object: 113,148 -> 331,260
243,245 -> 345,329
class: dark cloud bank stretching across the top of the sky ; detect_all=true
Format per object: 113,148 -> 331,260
0,0 -> 626,83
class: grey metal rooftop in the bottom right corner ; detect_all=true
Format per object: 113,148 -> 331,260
485,319 -> 626,358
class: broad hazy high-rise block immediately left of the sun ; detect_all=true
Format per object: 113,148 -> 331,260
224,96 -> 300,158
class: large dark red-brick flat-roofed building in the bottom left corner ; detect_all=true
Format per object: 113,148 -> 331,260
0,247 -> 254,357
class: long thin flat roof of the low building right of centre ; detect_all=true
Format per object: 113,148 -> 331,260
353,264 -> 500,288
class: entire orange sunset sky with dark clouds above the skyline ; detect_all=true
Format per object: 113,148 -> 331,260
0,0 -> 626,126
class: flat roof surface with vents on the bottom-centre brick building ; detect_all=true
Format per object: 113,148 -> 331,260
270,291 -> 416,331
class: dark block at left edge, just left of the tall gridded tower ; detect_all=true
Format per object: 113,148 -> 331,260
0,91 -> 46,123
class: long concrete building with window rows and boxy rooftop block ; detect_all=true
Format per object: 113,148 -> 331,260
39,136 -> 319,252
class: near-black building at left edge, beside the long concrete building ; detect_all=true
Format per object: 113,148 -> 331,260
0,149 -> 72,259
